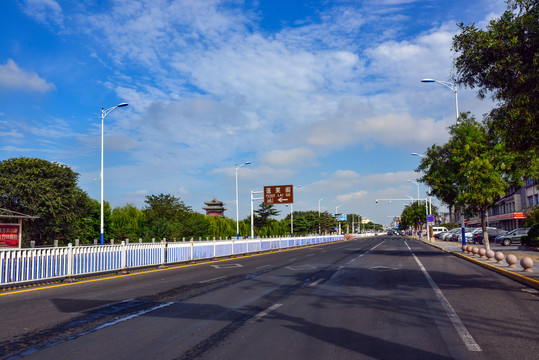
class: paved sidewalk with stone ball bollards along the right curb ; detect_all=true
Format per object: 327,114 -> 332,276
411,238 -> 539,290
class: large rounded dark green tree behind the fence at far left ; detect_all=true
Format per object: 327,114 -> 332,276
0,157 -> 91,245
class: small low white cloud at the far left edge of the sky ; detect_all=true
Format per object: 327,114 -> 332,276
0,59 -> 55,92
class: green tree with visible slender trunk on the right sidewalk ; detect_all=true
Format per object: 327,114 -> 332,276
419,113 -> 522,249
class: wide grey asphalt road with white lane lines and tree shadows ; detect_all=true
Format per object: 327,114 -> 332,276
0,236 -> 539,360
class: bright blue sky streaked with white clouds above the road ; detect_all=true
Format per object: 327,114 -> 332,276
0,0 -> 506,224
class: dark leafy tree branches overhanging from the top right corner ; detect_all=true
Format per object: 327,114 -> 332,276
453,0 -> 539,155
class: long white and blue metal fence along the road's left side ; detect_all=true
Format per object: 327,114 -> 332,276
0,235 -> 343,285
